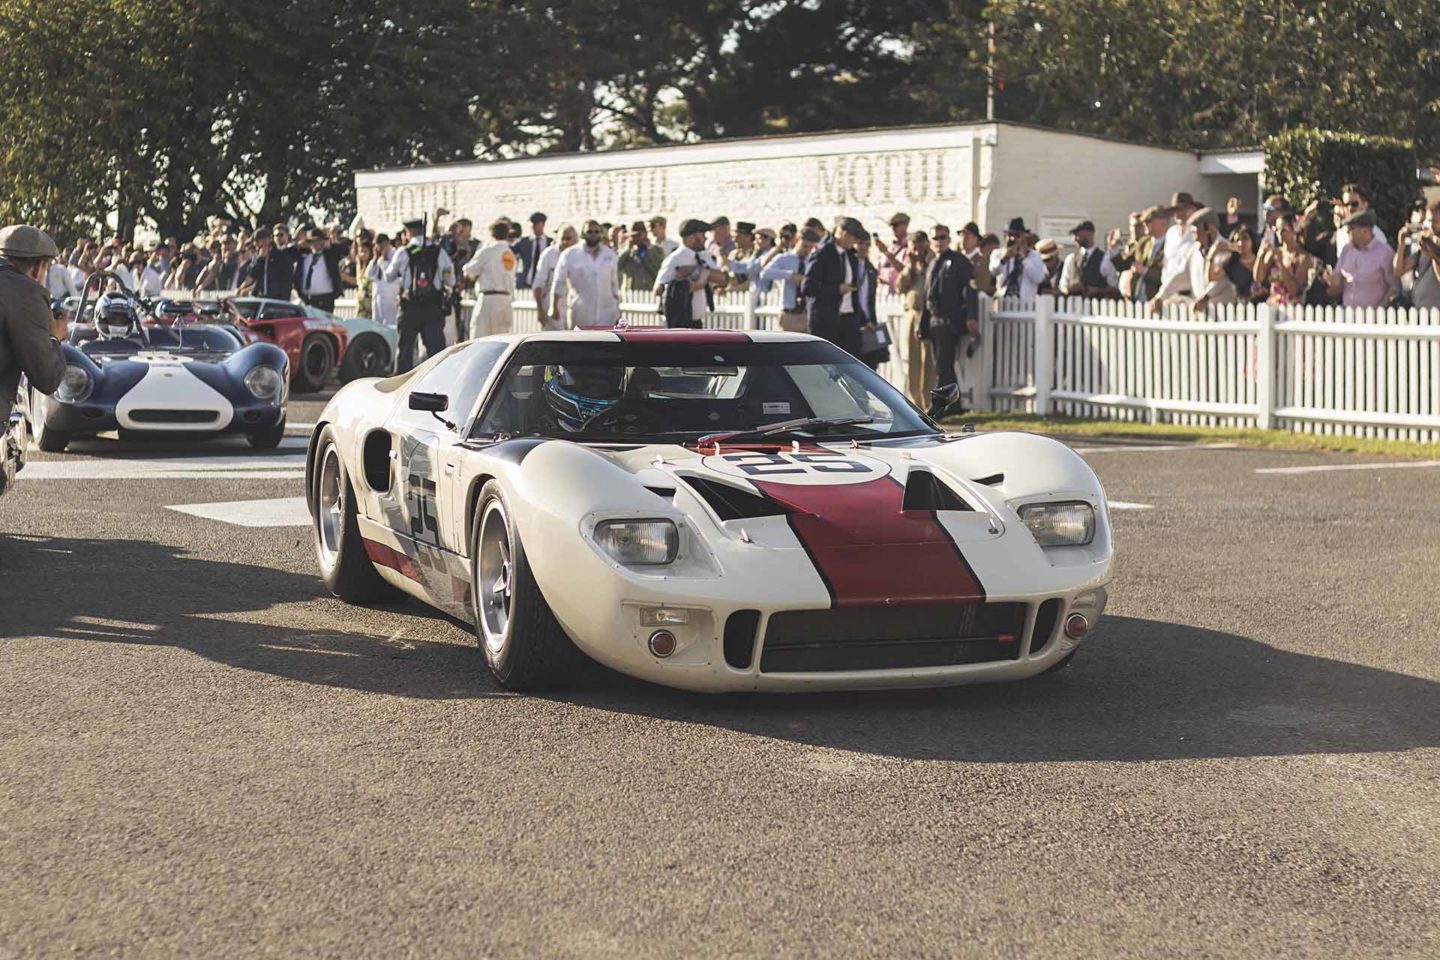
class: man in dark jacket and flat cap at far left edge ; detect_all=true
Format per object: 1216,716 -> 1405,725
0,225 -> 68,431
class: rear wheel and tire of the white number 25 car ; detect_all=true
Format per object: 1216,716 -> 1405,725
310,426 -> 405,606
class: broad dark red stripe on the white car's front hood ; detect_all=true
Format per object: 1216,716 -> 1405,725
753,476 -> 985,606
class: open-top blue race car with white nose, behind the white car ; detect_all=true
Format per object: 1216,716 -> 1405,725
19,284 -> 289,452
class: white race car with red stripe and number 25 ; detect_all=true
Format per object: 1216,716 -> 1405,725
307,328 -> 1112,691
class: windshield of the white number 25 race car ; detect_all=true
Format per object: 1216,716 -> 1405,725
472,340 -> 935,442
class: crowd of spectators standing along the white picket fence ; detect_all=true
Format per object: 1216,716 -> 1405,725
49,184 -> 1440,391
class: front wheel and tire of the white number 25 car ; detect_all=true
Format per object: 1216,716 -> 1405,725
469,481 -> 585,692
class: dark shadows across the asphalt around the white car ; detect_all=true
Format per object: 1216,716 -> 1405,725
0,537 -> 1440,763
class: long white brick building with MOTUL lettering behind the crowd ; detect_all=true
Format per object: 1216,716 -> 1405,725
356,122 -> 1238,240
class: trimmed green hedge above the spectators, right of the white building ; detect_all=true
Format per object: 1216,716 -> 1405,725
1264,128 -> 1420,239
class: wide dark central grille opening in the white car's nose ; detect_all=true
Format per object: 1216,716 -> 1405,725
760,603 -> 1030,674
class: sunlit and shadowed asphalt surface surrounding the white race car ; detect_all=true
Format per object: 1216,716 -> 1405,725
0,403 -> 1440,960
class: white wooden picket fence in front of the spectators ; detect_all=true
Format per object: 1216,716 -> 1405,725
182,284 -> 1440,442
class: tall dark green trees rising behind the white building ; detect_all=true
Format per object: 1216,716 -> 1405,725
0,0 -> 1440,235
